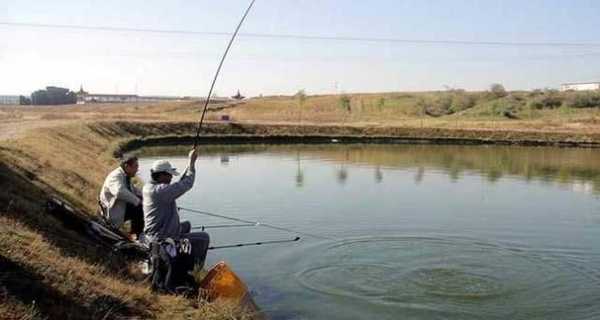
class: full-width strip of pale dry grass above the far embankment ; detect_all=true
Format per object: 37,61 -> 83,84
0,92 -> 600,139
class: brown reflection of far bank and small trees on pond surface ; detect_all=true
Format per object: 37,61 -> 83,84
135,144 -> 600,193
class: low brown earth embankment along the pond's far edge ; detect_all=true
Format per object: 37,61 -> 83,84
115,122 -> 600,153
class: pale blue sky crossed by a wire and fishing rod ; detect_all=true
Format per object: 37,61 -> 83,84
0,0 -> 600,96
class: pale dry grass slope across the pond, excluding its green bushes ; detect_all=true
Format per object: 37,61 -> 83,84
215,92 -> 600,132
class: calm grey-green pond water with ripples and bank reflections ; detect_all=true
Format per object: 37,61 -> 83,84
140,144 -> 600,319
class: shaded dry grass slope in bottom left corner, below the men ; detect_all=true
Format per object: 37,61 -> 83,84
0,217 -> 250,319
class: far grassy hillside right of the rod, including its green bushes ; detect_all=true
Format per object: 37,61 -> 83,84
221,90 -> 600,130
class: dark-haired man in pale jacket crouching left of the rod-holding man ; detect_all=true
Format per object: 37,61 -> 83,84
99,155 -> 144,240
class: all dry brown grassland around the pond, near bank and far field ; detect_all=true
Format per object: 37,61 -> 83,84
0,93 -> 600,319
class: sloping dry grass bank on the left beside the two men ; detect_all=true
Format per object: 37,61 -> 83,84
0,123 -> 255,319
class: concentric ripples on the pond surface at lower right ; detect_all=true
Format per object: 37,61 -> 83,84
298,237 -> 600,318
